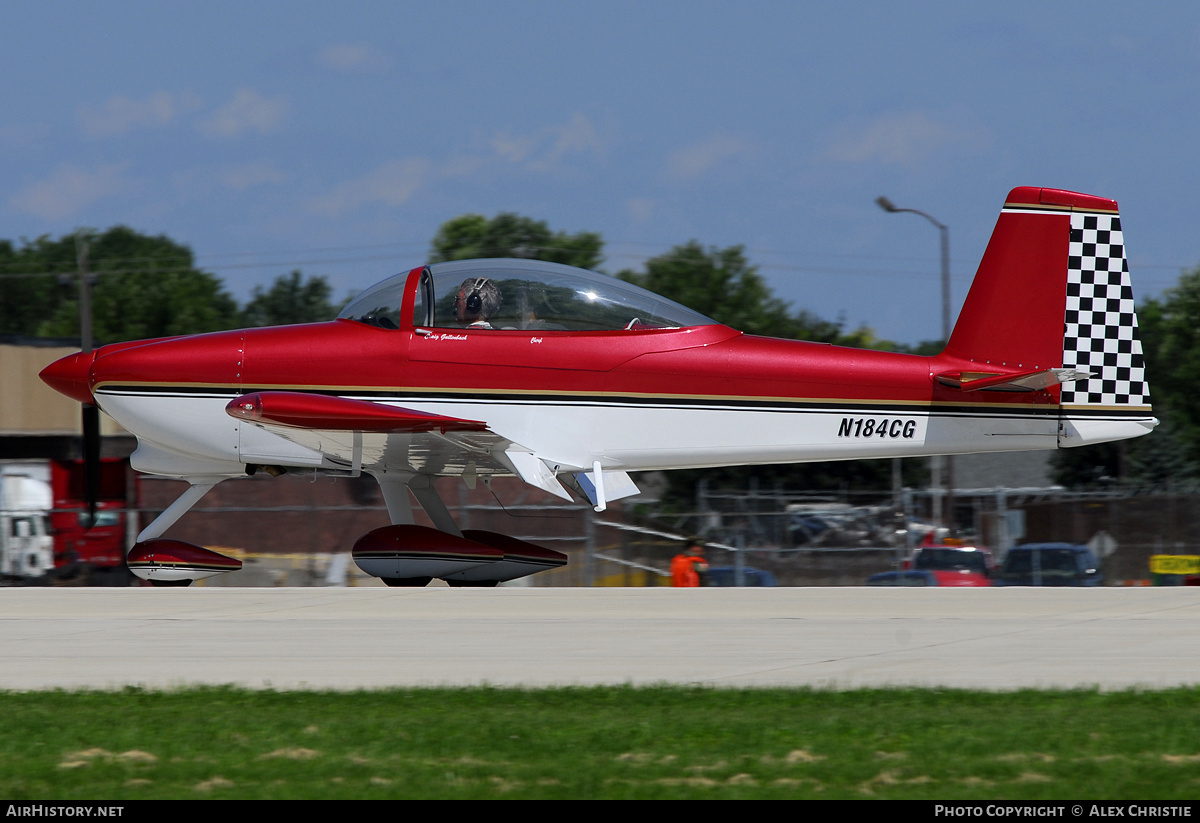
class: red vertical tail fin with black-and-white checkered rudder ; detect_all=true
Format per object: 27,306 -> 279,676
943,186 -> 1153,415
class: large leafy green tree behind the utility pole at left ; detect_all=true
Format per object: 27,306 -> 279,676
30,226 -> 238,343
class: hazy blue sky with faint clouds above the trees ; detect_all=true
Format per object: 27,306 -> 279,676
0,0 -> 1200,342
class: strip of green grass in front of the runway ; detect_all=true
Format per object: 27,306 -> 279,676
0,686 -> 1200,800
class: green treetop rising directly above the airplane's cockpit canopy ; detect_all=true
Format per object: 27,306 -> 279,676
430,212 -> 604,269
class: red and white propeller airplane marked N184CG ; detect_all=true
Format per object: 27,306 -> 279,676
42,187 -> 1158,585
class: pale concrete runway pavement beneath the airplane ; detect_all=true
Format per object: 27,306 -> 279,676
0,588 -> 1200,690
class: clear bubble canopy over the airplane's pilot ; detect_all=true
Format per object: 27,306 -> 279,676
337,259 -> 716,331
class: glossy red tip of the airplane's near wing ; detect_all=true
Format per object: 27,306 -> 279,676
226,391 -> 487,433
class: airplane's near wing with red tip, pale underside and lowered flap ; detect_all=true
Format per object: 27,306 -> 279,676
226,391 -> 580,500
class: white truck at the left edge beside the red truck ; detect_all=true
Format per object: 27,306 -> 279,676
0,463 -> 54,579
